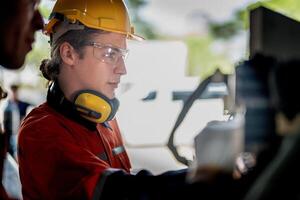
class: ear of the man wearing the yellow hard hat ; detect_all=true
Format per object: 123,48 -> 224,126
59,42 -> 79,65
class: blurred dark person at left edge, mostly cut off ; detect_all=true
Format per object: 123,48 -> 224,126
0,0 -> 43,199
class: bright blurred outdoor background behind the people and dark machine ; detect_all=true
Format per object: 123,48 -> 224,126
0,0 -> 300,173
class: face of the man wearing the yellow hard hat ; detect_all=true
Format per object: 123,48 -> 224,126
72,33 -> 126,98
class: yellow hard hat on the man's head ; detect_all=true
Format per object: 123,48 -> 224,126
44,0 -> 142,40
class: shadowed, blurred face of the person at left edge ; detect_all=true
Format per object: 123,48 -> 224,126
4,0 -> 43,69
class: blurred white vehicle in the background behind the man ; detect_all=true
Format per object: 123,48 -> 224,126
117,41 -> 227,174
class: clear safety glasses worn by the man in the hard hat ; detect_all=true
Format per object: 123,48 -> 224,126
86,42 -> 129,66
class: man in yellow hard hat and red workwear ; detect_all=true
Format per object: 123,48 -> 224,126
18,0 -> 234,200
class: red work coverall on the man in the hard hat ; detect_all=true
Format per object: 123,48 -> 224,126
19,103 -> 131,200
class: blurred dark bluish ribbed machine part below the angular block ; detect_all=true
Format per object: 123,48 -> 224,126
236,54 -> 276,153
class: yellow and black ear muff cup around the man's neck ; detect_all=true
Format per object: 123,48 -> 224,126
73,90 -> 119,123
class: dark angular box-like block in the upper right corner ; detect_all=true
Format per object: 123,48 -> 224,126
250,7 -> 300,60
